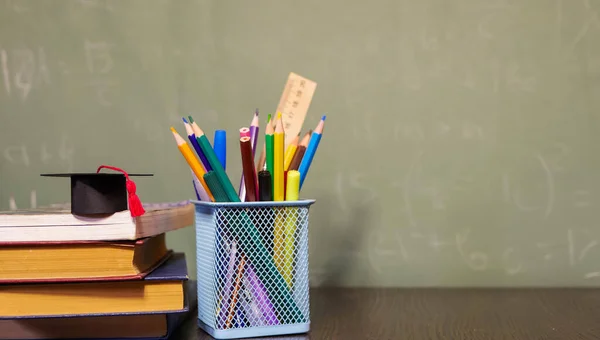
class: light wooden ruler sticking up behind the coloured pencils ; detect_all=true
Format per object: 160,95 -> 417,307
273,72 -> 317,147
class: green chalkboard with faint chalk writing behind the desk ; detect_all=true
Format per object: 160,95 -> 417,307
0,0 -> 600,286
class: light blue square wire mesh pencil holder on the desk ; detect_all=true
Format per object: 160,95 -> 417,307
193,200 -> 315,339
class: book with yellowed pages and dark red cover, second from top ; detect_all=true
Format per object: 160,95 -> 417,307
0,234 -> 171,283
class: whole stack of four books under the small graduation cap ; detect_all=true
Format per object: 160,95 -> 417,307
0,201 -> 196,339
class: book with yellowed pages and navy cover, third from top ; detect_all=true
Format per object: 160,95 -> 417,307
0,254 -> 188,318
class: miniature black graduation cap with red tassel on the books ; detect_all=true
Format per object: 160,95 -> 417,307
41,165 -> 153,217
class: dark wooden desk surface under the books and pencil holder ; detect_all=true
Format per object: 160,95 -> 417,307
173,288 -> 600,340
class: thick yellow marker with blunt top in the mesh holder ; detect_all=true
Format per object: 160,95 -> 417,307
282,170 -> 300,288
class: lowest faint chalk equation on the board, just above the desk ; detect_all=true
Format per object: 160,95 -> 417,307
361,228 -> 600,279
